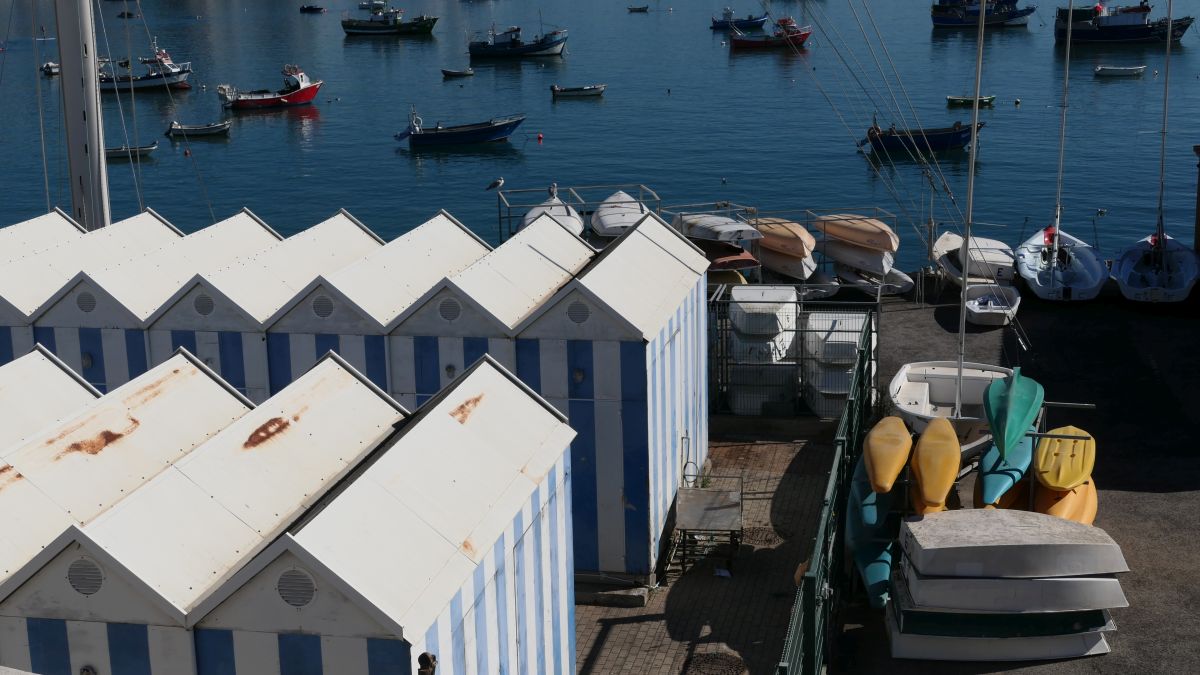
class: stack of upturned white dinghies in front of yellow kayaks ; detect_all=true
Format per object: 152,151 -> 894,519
887,509 -> 1129,661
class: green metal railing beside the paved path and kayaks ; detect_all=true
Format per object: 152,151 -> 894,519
775,313 -> 877,675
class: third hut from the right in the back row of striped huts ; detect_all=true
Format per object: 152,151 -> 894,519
266,211 -> 491,393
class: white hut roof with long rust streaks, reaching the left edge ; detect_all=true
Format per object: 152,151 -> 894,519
0,351 -> 252,579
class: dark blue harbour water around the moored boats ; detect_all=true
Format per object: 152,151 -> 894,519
0,0 -> 1200,269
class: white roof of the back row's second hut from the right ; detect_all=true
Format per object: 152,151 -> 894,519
450,215 -> 595,328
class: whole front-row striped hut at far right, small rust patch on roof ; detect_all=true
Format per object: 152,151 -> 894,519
189,358 -> 575,675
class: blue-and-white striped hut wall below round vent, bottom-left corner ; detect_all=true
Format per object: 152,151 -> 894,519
0,616 -> 196,675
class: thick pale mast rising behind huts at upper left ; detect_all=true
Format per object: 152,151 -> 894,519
54,0 -> 110,229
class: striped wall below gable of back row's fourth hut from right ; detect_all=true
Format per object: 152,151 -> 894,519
146,330 -> 272,404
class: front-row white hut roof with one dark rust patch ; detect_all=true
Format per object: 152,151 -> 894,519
84,354 -> 406,614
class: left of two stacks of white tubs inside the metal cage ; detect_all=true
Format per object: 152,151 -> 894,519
727,286 -> 800,416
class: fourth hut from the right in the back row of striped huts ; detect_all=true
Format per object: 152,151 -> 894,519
146,210 -> 383,402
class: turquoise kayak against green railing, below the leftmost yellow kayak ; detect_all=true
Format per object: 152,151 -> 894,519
846,458 -> 899,609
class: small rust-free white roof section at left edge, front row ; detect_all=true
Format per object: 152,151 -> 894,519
0,345 -> 100,453
